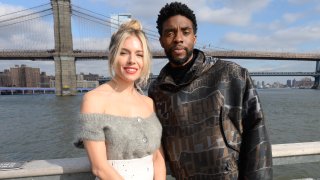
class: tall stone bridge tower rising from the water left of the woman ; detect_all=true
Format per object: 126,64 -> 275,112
51,0 -> 77,96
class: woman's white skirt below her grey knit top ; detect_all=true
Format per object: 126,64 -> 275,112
96,155 -> 154,180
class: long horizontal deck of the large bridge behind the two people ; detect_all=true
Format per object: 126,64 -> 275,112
0,50 -> 320,61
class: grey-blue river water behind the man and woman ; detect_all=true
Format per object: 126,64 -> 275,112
0,89 -> 320,180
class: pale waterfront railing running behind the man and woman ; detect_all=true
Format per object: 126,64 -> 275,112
0,141 -> 320,180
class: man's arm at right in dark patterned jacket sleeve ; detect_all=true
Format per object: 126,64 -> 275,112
239,72 -> 272,180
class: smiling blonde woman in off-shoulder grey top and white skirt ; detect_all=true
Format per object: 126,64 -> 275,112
76,20 -> 166,180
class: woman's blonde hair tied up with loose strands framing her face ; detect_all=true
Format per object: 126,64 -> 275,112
109,20 -> 152,86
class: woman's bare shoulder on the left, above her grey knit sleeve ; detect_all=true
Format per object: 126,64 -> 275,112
81,86 -> 112,113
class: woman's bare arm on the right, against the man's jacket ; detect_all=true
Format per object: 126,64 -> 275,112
153,147 -> 167,180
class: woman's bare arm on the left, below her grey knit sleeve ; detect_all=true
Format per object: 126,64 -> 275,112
84,140 -> 123,180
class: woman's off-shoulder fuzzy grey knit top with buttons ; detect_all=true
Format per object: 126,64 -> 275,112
75,113 -> 162,160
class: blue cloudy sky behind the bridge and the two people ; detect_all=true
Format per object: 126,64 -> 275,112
0,0 -> 320,83
